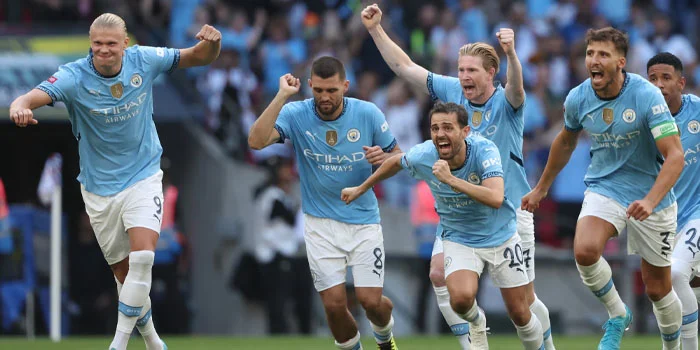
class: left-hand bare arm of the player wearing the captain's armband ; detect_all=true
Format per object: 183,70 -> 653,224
521,128 -> 578,212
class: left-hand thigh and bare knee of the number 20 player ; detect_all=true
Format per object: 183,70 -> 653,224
443,241 -> 485,298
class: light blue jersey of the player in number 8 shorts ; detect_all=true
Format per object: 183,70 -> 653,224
275,97 -> 396,224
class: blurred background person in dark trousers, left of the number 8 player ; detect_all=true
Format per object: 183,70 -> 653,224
254,157 -> 312,334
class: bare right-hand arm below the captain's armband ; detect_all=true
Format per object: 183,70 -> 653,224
627,133 -> 684,221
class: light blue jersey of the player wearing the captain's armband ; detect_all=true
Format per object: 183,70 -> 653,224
564,73 -> 678,212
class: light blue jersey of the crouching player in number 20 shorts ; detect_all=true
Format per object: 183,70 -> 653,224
401,135 -> 516,248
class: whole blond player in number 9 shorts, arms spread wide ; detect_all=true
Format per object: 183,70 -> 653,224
10,13 -> 221,350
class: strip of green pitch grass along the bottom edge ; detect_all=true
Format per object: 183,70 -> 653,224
0,334 -> 661,350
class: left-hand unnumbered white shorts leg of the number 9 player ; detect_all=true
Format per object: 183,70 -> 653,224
80,185 -> 130,264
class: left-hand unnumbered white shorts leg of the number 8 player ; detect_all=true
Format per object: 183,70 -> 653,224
304,215 -> 347,292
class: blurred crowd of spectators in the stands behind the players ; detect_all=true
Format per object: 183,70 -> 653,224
168,0 -> 700,247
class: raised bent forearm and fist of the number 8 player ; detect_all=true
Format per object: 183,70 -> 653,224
248,73 -> 301,149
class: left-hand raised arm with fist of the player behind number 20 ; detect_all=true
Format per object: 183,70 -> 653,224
362,4 -> 429,94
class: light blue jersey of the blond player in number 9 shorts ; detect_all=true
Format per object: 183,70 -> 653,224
36,46 -> 180,196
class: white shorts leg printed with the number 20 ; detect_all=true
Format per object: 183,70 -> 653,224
477,233 -> 530,288
